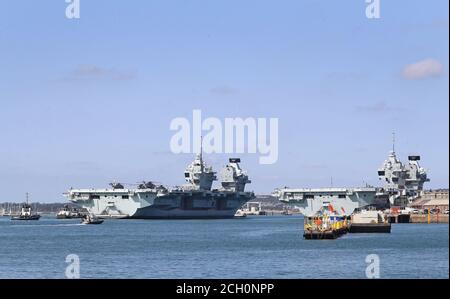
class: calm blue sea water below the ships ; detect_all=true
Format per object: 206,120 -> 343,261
0,216 -> 449,278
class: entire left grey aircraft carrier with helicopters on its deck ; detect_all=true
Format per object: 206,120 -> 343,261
67,153 -> 255,219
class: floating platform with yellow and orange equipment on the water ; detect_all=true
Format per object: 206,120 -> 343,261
303,215 -> 348,240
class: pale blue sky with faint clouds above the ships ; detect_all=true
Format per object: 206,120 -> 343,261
0,0 -> 449,202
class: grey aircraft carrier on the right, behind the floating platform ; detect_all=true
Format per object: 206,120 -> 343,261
272,135 -> 430,217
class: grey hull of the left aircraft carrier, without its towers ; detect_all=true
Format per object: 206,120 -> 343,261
69,189 -> 255,219
